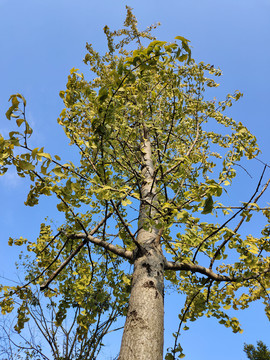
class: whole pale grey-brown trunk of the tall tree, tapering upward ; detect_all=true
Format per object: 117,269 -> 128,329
118,132 -> 164,360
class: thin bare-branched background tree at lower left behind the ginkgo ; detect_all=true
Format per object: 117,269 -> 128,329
0,269 -> 120,360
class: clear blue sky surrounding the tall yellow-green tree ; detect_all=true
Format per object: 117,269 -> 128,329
0,0 -> 270,360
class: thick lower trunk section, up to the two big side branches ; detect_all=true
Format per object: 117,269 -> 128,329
118,245 -> 164,360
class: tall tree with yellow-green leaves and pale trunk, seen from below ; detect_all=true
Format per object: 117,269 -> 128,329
0,8 -> 270,360
